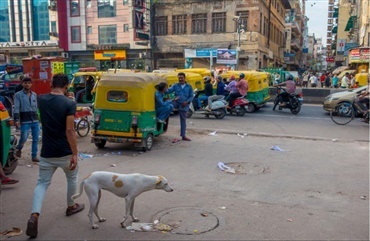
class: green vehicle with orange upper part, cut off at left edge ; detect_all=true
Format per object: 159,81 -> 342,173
0,101 -> 18,175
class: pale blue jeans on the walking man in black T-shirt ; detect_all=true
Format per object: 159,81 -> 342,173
32,156 -> 78,214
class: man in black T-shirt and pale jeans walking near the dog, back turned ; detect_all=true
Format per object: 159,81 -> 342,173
26,74 -> 85,238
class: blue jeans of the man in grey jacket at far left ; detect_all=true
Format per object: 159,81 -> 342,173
17,122 -> 40,158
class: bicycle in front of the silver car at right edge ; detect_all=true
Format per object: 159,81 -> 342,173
330,96 -> 369,125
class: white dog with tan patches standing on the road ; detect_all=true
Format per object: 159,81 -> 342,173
72,172 -> 173,229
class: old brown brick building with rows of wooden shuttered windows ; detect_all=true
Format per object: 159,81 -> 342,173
154,0 -> 290,69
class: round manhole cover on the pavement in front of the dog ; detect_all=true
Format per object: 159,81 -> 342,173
153,207 -> 219,235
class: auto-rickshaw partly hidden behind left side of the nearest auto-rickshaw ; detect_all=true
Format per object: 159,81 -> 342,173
68,71 -> 102,103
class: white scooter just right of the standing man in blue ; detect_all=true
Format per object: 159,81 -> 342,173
186,90 -> 227,119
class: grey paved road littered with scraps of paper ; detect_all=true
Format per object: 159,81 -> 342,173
0,106 -> 369,240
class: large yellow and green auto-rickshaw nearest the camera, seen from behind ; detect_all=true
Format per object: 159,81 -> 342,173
92,73 -> 168,151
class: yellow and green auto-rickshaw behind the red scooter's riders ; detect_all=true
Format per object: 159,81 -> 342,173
220,70 -> 270,113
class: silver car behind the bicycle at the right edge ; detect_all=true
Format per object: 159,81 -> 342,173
323,86 -> 366,111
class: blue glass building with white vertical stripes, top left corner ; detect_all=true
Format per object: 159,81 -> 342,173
0,0 -> 60,63
